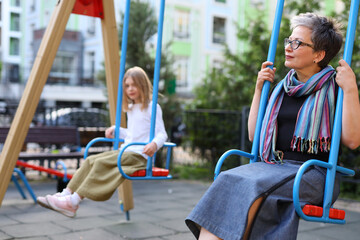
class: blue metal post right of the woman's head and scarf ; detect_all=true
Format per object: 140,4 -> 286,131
323,0 -> 359,219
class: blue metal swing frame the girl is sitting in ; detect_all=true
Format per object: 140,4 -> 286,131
84,0 -> 176,180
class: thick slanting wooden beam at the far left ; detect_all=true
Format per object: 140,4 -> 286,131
0,0 -> 76,206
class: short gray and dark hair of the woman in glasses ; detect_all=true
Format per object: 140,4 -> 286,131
291,13 -> 343,68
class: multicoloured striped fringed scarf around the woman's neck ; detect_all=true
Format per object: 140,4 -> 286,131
260,66 -> 336,163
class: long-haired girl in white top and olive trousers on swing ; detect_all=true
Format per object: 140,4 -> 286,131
37,67 -> 168,217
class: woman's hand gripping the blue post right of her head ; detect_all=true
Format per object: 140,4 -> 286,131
335,59 -> 357,93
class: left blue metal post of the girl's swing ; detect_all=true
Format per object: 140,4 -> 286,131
113,0 -> 131,150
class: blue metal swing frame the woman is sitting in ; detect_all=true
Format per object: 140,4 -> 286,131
215,0 -> 359,224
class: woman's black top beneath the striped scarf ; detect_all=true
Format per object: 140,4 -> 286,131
276,91 -> 337,161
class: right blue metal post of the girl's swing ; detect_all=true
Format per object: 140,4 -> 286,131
146,0 -> 165,176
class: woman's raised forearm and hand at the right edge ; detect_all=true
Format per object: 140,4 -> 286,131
336,59 -> 360,149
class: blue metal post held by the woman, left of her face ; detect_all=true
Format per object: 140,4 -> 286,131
250,0 -> 285,163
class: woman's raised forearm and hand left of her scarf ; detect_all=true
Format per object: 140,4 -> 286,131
248,61 -> 276,142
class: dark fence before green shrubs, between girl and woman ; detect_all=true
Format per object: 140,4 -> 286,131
184,107 -> 251,167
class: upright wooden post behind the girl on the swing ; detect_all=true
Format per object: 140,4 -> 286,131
101,1 -> 134,211
